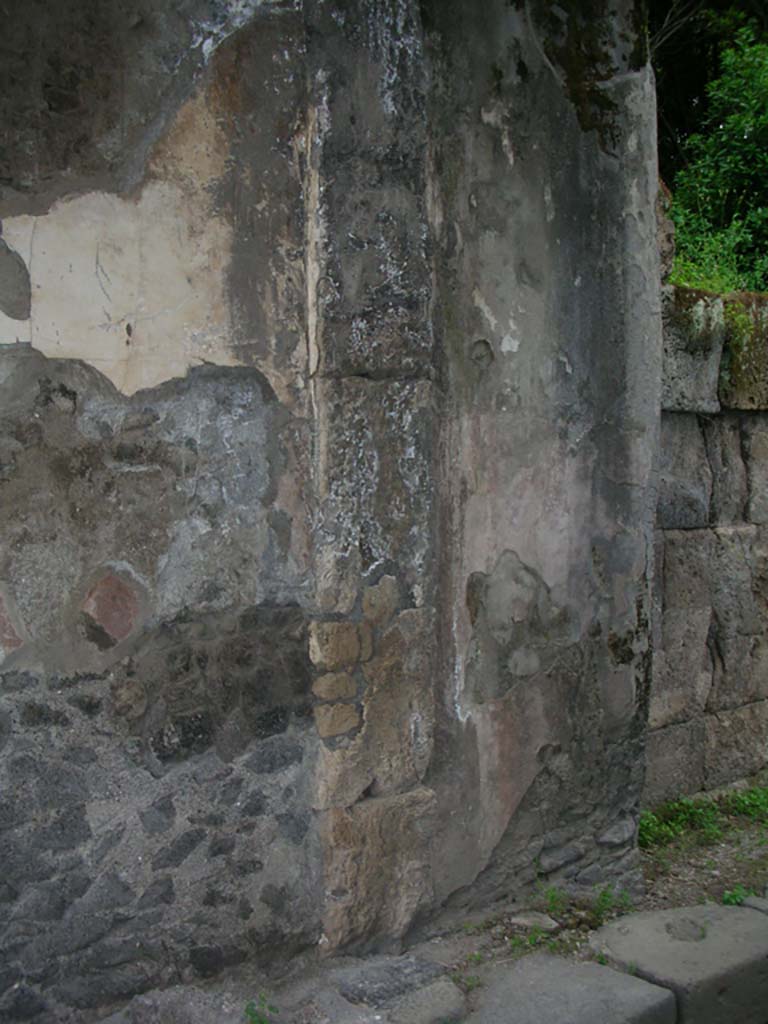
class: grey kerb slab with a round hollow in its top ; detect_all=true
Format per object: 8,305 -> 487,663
591,904 -> 768,1024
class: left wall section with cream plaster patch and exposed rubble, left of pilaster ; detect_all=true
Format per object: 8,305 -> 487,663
0,2 -> 325,1021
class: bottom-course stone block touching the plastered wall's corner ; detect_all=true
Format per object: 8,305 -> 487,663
643,718 -> 705,807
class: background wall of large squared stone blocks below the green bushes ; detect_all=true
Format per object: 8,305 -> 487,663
645,287 -> 768,804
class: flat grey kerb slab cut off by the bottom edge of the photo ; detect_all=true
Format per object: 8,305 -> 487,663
466,955 -> 676,1024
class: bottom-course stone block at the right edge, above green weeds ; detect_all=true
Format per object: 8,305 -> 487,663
703,700 -> 768,788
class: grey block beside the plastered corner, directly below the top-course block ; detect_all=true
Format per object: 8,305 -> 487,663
658,413 -> 713,529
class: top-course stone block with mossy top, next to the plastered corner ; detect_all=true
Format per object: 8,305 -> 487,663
662,285 -> 725,413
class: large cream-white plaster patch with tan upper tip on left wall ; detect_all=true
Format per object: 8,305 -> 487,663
0,87 -> 234,394
